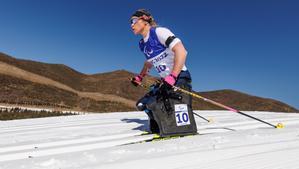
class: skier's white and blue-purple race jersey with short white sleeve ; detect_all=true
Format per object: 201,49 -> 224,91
139,27 -> 187,78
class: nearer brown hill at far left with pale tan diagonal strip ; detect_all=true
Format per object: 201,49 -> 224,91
0,53 -> 135,112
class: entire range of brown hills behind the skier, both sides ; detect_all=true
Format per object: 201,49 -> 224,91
0,53 -> 298,112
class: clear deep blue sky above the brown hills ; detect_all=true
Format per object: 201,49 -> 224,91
0,0 -> 299,108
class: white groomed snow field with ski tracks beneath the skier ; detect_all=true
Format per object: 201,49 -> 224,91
0,111 -> 299,169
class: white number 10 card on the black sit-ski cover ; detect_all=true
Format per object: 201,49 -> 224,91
174,104 -> 190,126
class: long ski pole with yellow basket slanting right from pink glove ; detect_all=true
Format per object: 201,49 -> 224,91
173,86 -> 284,128
